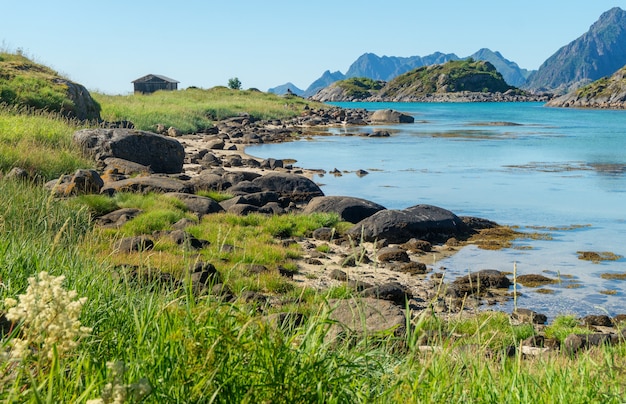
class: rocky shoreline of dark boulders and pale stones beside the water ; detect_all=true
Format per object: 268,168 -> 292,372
28,108 -> 624,354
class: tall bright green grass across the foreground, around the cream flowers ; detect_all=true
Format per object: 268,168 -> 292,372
0,181 -> 626,403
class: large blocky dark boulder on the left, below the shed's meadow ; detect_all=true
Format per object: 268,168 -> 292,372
73,128 -> 185,174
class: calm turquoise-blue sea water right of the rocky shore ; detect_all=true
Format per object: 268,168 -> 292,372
247,103 -> 626,317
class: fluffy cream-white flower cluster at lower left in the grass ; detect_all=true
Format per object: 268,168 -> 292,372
4,272 -> 91,360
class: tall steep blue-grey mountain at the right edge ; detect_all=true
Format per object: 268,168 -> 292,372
525,7 -> 626,93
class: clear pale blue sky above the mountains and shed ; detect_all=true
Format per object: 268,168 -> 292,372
0,0 -> 626,94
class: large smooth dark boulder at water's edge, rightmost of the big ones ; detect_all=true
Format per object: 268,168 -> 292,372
347,205 -> 472,244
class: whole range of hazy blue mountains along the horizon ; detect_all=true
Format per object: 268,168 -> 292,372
268,7 -> 626,97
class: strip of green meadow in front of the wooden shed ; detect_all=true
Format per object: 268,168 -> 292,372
92,87 -> 316,133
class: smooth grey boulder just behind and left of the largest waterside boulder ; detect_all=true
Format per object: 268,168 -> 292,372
303,196 -> 385,223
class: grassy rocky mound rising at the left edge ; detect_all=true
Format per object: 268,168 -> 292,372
0,53 -> 100,120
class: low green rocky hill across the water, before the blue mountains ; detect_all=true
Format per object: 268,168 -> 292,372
311,59 -> 516,102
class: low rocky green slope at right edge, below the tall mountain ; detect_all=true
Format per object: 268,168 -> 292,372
546,66 -> 626,109
